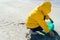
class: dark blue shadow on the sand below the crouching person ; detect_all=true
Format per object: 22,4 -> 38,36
30,31 -> 60,40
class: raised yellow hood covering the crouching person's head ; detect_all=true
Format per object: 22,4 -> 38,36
38,2 -> 51,15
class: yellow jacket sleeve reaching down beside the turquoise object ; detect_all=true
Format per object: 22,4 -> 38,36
34,15 -> 49,33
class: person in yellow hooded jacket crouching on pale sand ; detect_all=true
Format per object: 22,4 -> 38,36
26,1 -> 54,40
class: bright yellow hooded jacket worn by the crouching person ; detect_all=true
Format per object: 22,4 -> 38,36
26,2 -> 51,33
